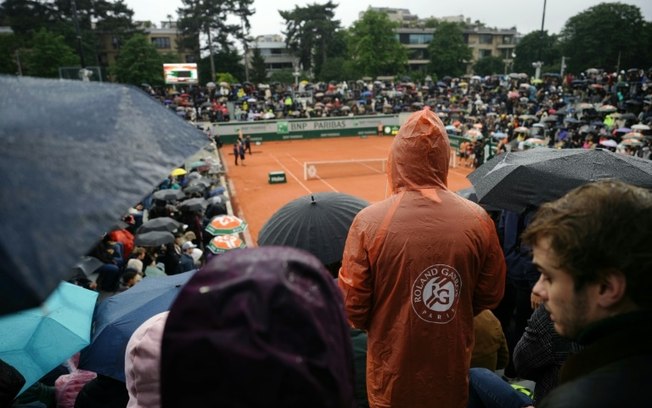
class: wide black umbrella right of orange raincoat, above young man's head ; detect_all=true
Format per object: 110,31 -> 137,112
468,149 -> 652,212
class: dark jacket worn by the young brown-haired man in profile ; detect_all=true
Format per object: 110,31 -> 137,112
537,311 -> 652,408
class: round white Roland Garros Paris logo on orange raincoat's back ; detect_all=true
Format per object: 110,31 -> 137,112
411,264 -> 462,324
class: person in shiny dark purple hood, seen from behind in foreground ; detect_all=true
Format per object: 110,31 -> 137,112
161,246 -> 354,408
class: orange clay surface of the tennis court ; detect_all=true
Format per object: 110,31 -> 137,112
220,136 -> 471,247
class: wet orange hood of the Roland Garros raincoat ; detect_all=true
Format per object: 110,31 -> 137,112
387,108 -> 450,193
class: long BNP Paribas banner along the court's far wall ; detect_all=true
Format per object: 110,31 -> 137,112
212,115 -> 399,143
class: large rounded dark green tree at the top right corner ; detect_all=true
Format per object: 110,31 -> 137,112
560,3 -> 652,72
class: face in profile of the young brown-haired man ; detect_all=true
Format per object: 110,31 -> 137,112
532,237 -> 595,339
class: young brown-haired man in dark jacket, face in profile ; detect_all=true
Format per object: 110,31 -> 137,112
522,181 -> 652,408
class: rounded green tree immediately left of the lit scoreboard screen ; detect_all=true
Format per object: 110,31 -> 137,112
111,34 -> 163,86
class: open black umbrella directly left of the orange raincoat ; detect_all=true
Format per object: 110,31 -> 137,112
258,193 -> 369,265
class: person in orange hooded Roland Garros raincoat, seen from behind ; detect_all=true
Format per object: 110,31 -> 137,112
338,109 -> 505,408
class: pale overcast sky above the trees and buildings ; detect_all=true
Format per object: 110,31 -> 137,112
125,0 -> 652,36
